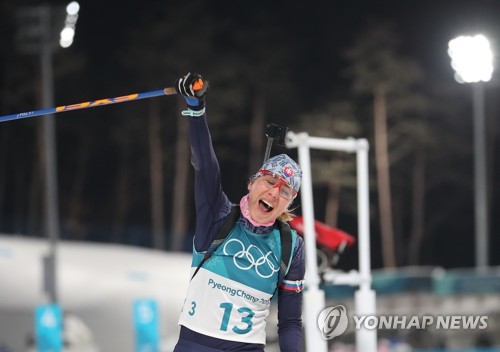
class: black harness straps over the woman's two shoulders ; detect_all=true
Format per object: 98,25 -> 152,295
191,205 -> 292,281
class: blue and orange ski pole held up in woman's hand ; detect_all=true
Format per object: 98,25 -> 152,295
0,79 -> 204,122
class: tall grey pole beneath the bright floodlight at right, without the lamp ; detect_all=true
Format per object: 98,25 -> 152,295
472,82 -> 489,269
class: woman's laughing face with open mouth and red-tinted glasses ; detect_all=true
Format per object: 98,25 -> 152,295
248,176 -> 295,224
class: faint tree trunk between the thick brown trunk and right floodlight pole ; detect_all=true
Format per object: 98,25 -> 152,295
408,145 -> 425,265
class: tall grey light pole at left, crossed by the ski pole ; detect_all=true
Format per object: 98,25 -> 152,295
40,5 -> 59,303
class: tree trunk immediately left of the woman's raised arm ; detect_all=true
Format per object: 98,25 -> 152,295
171,102 -> 190,251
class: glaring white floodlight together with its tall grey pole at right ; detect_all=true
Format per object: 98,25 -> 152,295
448,34 -> 493,268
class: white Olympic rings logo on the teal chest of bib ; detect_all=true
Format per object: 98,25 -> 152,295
224,238 -> 280,279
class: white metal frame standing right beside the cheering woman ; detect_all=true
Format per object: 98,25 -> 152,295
286,132 -> 377,352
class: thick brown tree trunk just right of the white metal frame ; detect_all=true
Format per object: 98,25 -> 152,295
374,85 -> 396,268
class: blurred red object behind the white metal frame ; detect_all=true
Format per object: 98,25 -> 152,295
289,216 -> 356,251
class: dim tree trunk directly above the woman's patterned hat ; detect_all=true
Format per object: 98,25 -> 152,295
248,93 -> 266,175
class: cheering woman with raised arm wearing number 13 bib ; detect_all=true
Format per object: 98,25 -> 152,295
174,73 -> 305,352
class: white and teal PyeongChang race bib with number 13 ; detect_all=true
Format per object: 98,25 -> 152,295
179,223 -> 295,344
